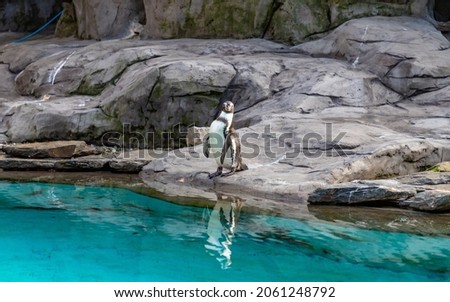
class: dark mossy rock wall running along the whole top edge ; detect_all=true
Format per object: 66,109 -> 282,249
0,0 -> 434,44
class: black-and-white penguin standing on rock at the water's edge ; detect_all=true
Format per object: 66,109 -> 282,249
203,101 -> 248,178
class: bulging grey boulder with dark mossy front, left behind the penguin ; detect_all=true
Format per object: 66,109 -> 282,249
101,53 -> 236,148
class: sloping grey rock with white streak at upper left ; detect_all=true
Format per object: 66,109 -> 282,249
15,41 -> 160,97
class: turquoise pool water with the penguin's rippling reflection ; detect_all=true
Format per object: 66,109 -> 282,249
0,182 -> 450,281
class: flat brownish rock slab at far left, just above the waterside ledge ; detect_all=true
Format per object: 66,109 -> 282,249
2,141 -> 100,158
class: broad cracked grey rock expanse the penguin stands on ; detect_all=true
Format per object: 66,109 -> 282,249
0,17 -> 450,211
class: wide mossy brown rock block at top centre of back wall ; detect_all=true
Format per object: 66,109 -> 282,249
144,0 -> 272,39
